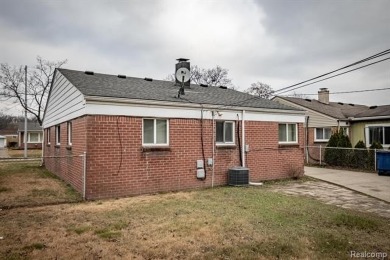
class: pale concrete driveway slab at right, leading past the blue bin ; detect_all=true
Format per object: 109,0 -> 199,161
305,167 -> 390,202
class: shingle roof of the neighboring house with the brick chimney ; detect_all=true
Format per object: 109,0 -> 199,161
279,97 -> 368,120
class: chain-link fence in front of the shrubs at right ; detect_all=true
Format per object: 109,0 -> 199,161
305,145 -> 388,171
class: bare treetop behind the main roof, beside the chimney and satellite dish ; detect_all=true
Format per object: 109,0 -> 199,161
165,65 -> 234,88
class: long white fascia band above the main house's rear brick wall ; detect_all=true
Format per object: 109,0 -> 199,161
85,96 -> 305,123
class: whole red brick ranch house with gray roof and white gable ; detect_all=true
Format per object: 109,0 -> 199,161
43,62 -> 305,199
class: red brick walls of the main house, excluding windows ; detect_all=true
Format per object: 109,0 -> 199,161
45,116 -> 303,199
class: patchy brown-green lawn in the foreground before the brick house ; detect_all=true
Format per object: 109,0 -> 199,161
0,187 -> 390,259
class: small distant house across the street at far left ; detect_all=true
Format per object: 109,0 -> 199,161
18,122 -> 43,149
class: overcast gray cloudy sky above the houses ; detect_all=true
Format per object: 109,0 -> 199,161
0,0 -> 390,114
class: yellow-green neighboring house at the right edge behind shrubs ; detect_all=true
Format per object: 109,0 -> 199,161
349,105 -> 390,149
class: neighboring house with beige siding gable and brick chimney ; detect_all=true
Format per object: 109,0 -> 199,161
273,88 -> 368,161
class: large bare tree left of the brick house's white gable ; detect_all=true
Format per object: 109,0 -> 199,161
0,56 -> 67,125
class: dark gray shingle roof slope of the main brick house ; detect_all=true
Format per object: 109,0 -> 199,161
58,69 -> 299,111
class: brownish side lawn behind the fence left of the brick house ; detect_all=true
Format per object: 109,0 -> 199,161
0,162 -> 81,208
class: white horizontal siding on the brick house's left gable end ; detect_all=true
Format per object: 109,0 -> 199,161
43,71 -> 85,128
